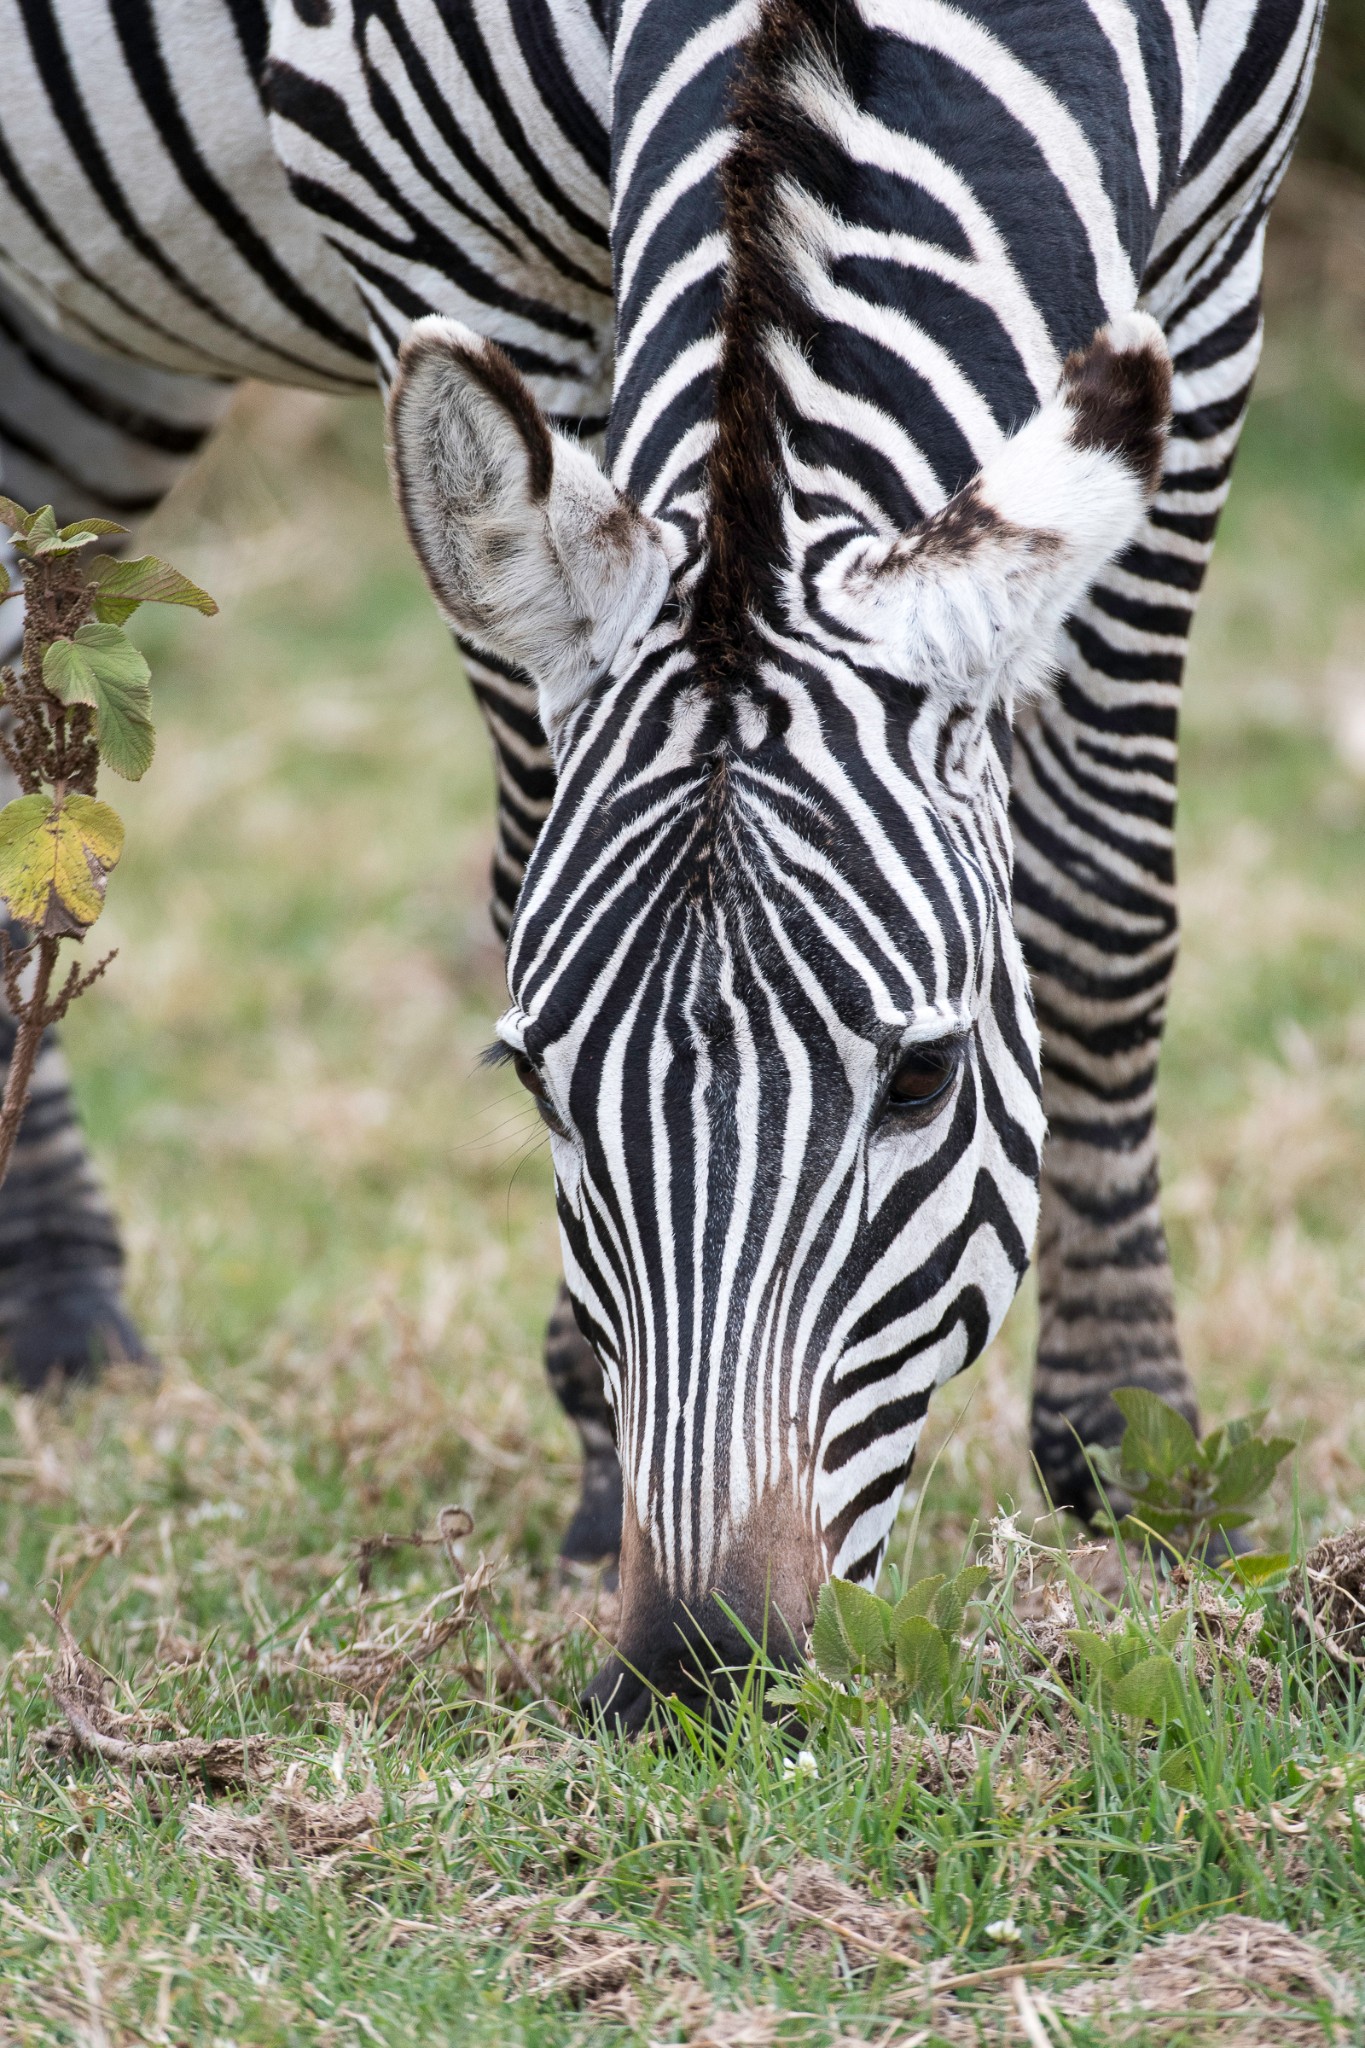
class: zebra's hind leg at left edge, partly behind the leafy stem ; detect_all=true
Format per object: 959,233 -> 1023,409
0,289 -> 231,1389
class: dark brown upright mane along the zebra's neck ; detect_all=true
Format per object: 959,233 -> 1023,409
688,0 -> 868,694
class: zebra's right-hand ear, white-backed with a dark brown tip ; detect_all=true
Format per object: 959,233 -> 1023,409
821,313 -> 1171,705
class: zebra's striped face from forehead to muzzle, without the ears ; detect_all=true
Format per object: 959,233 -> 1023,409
501,649 -> 1042,1708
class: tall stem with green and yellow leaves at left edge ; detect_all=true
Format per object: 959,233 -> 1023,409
0,498 -> 217,1180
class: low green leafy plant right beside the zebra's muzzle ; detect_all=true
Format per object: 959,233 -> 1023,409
769,1565 -> 990,1722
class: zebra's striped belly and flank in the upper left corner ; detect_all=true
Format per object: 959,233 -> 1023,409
0,0 -> 375,391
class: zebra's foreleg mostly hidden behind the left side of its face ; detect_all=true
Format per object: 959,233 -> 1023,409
460,645 -> 622,1563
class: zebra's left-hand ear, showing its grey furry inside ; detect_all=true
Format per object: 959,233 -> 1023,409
389,317 -> 669,737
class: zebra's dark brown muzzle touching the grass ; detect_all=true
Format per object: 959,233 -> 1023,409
583,1530 -> 823,1735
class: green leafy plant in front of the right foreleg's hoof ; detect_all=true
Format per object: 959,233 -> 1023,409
1087,1386 -> 1293,1579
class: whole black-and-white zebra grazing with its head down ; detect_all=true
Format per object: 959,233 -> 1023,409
0,0 -> 1318,1726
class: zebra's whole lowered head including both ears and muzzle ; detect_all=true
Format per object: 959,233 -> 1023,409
391,313 -> 1169,1726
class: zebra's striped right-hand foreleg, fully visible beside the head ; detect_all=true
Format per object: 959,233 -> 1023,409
1011,284 -> 1261,1518
